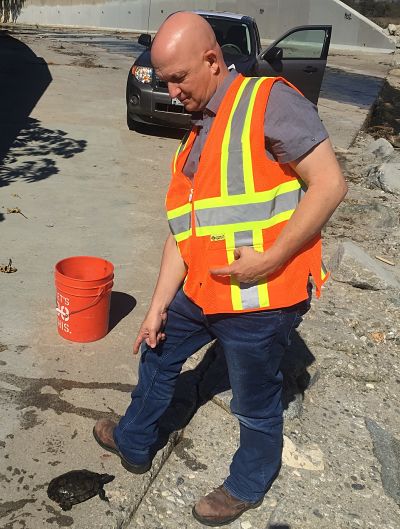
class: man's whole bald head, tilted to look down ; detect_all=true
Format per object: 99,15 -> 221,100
151,11 -> 228,112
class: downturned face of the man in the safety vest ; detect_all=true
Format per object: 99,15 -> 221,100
155,54 -> 216,112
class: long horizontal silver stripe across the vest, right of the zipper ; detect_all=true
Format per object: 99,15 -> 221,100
195,188 -> 303,227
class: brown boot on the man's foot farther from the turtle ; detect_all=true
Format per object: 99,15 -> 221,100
192,485 -> 262,527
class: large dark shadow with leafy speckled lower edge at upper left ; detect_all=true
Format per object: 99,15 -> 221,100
0,30 -> 87,196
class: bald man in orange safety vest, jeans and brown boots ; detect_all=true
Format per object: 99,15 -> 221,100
94,12 -> 347,525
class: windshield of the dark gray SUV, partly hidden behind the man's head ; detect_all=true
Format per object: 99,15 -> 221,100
204,17 -> 252,56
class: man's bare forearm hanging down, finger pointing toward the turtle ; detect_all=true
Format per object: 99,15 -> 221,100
133,234 -> 186,354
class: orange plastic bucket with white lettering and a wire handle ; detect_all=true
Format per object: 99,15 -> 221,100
54,255 -> 114,342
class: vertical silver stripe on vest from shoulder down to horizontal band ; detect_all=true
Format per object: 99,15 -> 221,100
228,78 -> 259,195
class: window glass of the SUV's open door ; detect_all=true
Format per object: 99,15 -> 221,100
275,29 -> 325,59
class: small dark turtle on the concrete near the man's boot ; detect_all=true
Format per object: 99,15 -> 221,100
47,469 -> 115,511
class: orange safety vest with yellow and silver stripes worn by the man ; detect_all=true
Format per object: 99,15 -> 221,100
166,75 -> 328,314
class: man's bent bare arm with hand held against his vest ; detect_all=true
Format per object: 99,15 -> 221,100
211,139 -> 347,283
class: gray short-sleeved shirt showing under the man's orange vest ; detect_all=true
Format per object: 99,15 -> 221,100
183,70 -> 328,178
